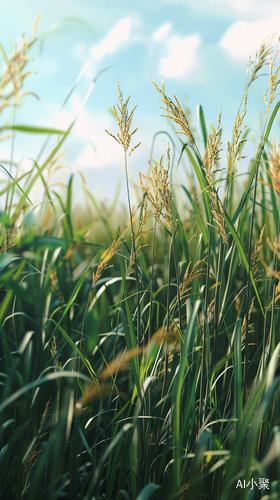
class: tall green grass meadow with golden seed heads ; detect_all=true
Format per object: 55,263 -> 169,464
0,20 -> 280,500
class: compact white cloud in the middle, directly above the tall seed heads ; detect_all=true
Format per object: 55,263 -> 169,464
160,34 -> 201,79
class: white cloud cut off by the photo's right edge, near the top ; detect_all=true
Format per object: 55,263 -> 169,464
220,19 -> 278,60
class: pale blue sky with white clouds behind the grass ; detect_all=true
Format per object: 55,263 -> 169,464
0,0 -> 280,207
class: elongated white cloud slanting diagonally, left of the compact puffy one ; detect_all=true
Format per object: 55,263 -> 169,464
91,17 -> 132,61
